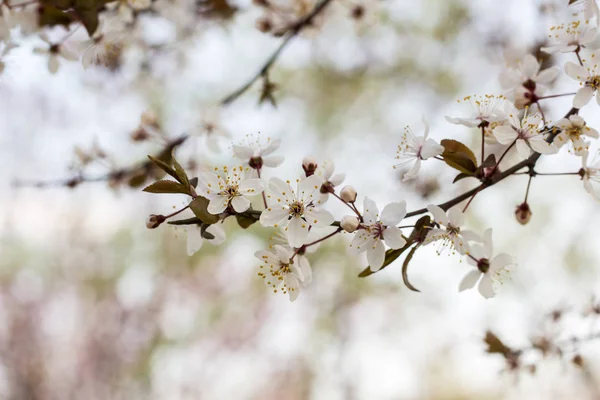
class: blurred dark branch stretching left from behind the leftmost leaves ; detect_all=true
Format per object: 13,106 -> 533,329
13,135 -> 188,189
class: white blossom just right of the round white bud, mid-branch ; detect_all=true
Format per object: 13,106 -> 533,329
350,197 -> 406,271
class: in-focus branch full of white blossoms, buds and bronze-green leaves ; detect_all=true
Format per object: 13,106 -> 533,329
138,1 -> 600,301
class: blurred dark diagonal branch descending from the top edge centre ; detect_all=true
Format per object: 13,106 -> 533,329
221,0 -> 332,106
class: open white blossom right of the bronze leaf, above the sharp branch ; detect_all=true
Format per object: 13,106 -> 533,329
494,102 -> 558,158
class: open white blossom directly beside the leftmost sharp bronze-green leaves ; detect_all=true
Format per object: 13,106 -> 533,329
198,165 -> 265,214
